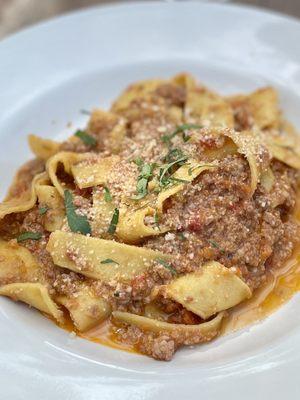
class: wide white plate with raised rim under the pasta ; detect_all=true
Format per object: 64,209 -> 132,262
0,2 -> 300,400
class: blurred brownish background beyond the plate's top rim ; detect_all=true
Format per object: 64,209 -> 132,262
0,0 -> 300,39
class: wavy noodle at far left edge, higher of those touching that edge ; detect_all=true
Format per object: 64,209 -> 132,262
0,172 -> 47,219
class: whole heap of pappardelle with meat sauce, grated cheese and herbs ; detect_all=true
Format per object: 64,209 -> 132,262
0,74 -> 300,360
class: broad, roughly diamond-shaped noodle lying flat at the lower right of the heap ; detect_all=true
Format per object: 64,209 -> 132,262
163,261 -> 252,319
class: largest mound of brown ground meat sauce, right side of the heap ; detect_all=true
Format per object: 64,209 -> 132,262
145,156 -> 299,288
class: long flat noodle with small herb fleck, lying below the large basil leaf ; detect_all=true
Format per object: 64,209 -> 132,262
47,231 -> 168,282
